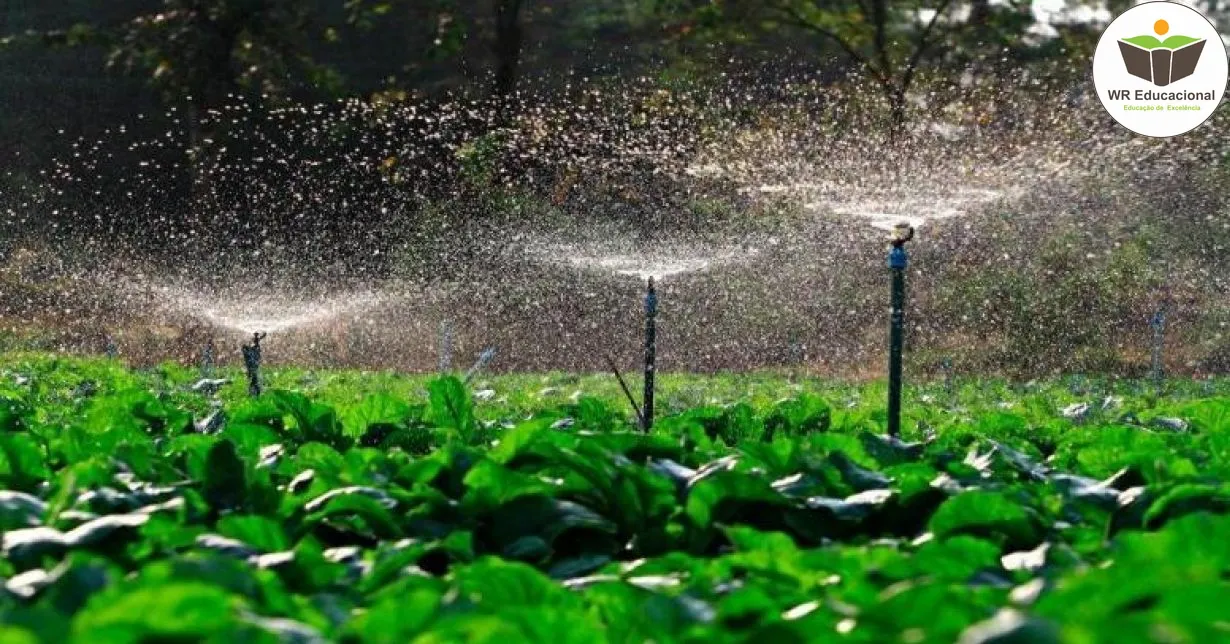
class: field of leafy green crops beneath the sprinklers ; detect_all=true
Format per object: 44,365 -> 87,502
0,355 -> 1230,644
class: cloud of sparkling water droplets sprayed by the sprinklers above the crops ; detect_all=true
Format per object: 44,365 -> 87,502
0,71 -> 1228,369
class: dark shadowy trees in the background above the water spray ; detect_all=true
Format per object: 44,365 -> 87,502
0,0 -> 1125,178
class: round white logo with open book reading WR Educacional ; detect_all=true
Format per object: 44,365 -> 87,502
1093,2 -> 1230,138
